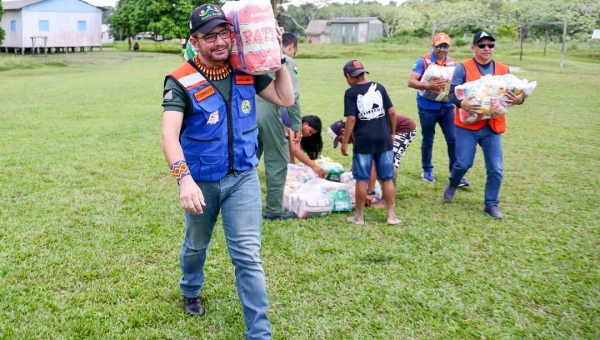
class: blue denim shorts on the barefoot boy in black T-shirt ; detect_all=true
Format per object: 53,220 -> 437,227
352,150 -> 394,182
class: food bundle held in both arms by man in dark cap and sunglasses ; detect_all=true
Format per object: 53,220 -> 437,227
454,74 -> 537,124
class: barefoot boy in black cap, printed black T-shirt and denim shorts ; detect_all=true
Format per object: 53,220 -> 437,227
341,60 -> 401,225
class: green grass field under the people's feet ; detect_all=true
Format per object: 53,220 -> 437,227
0,44 -> 600,339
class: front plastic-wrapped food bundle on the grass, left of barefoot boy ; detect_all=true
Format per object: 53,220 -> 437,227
288,178 -> 352,218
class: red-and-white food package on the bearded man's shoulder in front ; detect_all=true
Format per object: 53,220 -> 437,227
222,0 -> 281,74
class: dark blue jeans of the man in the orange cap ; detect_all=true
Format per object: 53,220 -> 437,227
419,106 -> 456,171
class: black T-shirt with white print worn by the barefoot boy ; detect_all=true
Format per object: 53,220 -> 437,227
344,82 -> 393,154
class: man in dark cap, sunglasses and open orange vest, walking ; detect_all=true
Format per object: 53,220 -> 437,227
444,31 -> 524,218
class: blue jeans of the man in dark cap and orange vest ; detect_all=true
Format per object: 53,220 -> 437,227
450,125 -> 503,205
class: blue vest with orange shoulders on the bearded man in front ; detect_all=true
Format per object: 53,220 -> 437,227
165,60 -> 258,182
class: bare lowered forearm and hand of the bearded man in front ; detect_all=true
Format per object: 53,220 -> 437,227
161,111 -> 206,214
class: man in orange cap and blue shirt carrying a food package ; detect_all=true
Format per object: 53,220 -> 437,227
408,32 -> 469,186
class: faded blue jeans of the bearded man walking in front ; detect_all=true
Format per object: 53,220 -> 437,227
179,169 -> 271,339
